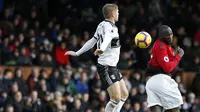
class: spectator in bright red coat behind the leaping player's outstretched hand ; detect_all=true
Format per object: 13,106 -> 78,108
55,42 -> 69,65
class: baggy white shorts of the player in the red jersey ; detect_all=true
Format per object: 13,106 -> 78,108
146,74 -> 183,110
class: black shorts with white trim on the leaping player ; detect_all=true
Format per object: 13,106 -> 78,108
97,64 -> 122,88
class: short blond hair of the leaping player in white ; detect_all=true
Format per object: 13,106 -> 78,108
102,4 -> 118,19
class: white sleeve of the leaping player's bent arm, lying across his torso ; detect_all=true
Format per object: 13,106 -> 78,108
100,25 -> 114,51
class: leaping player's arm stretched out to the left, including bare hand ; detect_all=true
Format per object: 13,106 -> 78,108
65,37 -> 97,56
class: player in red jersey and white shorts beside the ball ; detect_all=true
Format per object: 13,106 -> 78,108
146,25 -> 184,112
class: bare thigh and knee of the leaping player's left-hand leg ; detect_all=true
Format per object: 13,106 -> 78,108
107,81 -> 121,102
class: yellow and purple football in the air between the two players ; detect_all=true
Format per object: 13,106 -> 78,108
135,31 -> 152,48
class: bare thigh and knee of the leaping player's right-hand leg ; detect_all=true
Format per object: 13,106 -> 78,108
119,79 -> 129,99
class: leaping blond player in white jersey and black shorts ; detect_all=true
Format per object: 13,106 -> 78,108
65,4 -> 129,112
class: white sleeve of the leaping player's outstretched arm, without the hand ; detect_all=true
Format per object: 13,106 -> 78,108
76,38 -> 97,56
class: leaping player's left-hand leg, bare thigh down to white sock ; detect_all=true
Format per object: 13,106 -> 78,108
105,81 -> 121,112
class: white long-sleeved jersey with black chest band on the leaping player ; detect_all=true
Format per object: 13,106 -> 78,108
76,20 -> 121,66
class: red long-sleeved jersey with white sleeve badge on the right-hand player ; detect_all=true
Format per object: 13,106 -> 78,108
148,39 -> 181,73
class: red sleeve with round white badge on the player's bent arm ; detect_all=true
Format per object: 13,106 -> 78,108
156,47 -> 181,73
